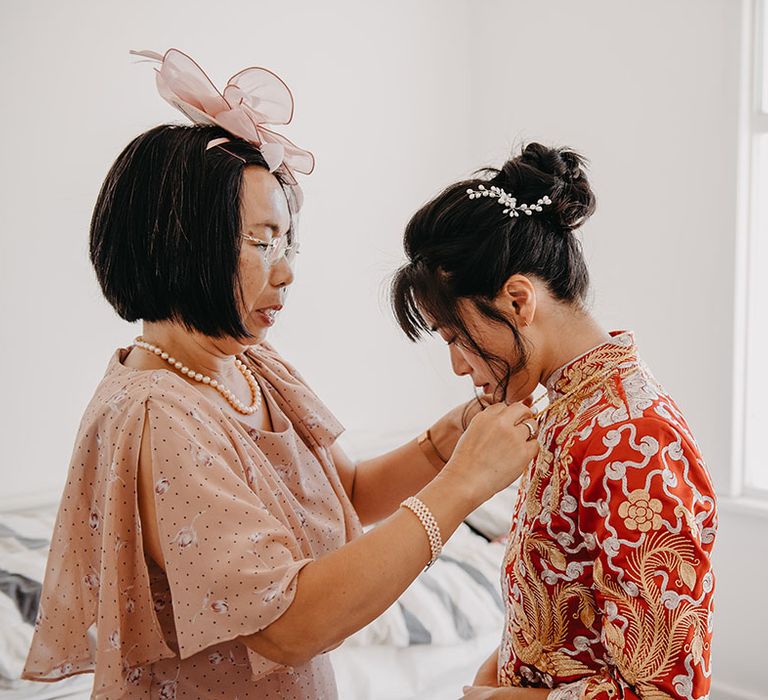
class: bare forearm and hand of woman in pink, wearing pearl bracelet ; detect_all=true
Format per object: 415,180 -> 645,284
243,404 -> 538,666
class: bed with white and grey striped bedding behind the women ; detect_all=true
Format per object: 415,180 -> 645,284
0,434 -> 514,700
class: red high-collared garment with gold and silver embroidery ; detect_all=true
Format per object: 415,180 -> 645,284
499,333 -> 717,700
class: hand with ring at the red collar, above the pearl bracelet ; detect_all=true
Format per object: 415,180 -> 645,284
441,403 -> 539,504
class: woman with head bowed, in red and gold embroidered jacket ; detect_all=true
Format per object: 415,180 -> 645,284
393,143 -> 716,700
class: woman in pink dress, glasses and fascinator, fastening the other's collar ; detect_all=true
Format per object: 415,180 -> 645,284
25,51 -> 537,700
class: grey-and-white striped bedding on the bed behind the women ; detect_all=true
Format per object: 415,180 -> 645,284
0,507 -> 504,700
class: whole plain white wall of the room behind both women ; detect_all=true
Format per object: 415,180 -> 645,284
0,0 -> 768,700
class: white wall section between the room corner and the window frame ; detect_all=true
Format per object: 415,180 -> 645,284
464,0 -> 739,492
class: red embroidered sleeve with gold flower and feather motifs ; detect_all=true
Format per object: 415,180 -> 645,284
579,418 -> 716,700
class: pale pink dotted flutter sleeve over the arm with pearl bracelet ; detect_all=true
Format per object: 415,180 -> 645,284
147,395 -> 311,678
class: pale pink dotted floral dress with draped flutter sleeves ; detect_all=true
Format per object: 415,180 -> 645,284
24,344 -> 361,700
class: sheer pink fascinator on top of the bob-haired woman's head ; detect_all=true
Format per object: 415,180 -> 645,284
131,49 -> 315,208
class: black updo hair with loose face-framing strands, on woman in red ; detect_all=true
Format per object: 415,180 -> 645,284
391,143 -> 595,392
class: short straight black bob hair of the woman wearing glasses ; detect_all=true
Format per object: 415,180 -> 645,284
90,124 -> 296,338
